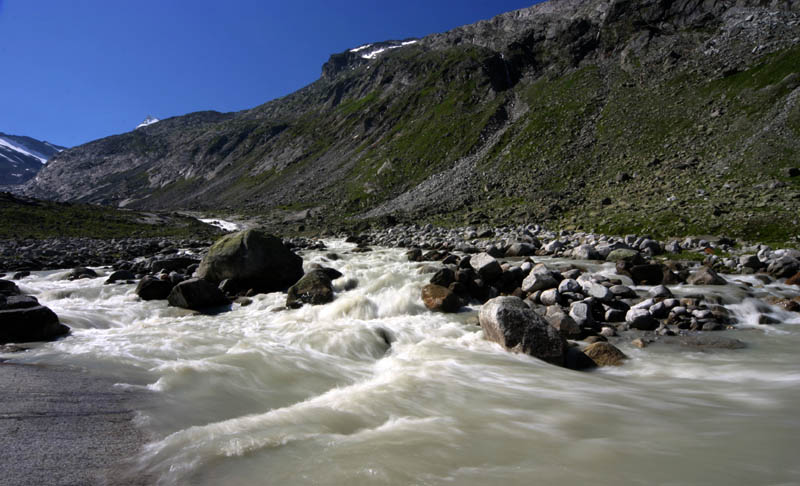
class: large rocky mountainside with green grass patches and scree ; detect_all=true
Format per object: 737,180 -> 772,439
20,0 -> 800,240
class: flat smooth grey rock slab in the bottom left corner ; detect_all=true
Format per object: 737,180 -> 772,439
0,362 -> 152,486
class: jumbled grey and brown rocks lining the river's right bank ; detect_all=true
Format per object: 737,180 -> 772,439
359,225 -> 800,368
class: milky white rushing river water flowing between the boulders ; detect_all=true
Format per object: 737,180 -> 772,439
4,242 -> 800,485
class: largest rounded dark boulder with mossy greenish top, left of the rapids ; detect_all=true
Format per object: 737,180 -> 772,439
197,229 -> 303,292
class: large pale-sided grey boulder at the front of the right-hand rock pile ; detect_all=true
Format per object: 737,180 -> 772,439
480,297 -> 567,366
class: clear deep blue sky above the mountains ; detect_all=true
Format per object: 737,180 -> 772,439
0,0 -> 537,146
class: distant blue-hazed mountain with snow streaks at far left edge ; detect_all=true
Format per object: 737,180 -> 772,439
0,133 -> 65,185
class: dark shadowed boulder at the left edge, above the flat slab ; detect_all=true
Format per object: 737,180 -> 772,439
0,295 -> 69,344
